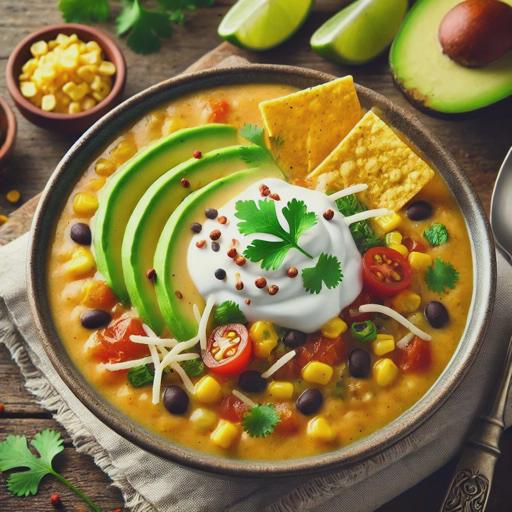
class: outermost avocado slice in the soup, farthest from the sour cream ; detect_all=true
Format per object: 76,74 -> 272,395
92,124 -> 238,303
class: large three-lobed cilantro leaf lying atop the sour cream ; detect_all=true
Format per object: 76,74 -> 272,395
235,199 -> 317,270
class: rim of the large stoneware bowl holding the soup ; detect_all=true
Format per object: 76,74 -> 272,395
28,64 -> 496,477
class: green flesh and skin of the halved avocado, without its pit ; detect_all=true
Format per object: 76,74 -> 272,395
389,0 -> 512,114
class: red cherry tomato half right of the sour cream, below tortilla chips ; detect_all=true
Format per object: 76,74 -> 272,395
363,247 -> 412,297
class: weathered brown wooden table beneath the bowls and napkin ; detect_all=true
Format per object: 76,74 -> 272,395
0,0 -> 512,512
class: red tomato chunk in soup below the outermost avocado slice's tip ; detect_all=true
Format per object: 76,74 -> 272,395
88,315 -> 149,363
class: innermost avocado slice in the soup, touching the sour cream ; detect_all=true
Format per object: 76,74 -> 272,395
154,167 -> 284,340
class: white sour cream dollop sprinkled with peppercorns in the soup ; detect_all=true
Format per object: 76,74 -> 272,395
187,179 -> 362,333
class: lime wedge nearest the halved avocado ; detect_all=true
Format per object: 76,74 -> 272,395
310,0 -> 408,64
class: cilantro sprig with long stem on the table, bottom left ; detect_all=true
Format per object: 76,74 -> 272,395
0,429 -> 101,512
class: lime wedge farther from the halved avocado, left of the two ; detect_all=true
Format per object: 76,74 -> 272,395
218,0 -> 313,50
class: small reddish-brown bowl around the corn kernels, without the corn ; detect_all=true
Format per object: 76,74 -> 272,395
6,23 -> 126,133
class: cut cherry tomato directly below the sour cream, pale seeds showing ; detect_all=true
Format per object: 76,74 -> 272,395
203,324 -> 252,376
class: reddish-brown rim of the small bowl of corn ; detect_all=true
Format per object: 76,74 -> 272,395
5,23 -> 126,121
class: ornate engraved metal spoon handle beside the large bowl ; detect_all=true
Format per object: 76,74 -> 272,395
440,338 -> 512,512
